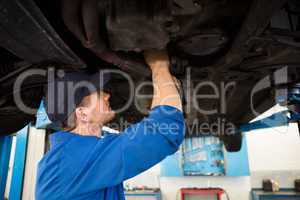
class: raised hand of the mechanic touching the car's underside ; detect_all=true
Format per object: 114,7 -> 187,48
144,50 -> 170,72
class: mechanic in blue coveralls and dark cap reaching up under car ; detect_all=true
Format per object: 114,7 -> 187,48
35,50 -> 185,200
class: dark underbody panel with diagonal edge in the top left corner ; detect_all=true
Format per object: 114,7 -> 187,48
0,0 -> 83,66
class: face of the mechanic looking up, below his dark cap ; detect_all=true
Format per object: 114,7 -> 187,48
84,91 -> 115,125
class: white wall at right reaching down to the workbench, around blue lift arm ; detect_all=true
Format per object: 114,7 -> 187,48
247,106 -> 300,188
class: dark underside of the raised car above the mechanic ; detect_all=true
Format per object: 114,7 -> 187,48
0,0 -> 300,150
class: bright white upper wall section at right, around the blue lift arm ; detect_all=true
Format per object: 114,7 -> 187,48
247,106 -> 300,171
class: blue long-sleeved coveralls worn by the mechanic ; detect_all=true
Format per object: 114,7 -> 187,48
35,105 -> 185,200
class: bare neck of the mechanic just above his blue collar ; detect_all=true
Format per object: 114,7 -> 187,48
72,123 -> 102,137
